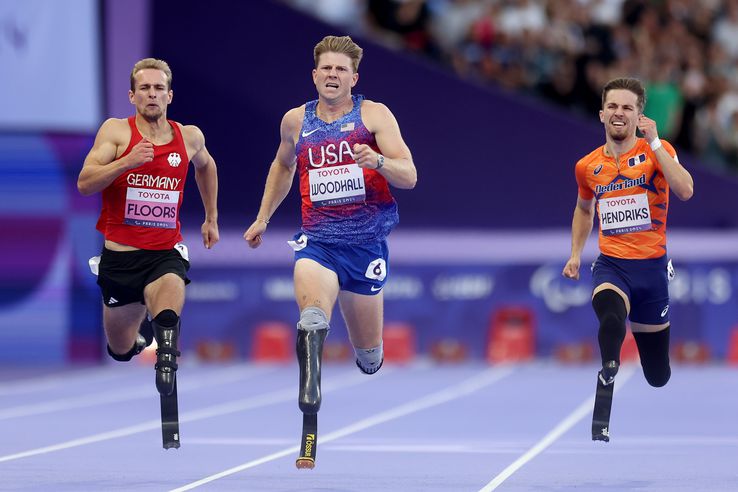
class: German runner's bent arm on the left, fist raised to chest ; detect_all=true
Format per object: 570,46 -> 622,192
77,118 -> 154,196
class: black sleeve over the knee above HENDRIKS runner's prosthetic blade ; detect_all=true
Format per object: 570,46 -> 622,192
592,289 -> 628,366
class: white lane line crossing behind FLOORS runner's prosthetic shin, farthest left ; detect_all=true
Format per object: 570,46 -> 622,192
0,367 -> 276,420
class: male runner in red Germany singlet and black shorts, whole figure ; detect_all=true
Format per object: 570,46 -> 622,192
77,58 -> 219,448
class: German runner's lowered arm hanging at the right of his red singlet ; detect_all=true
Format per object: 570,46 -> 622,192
183,125 -> 220,249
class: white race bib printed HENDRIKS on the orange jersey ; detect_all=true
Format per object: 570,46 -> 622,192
599,193 -> 651,236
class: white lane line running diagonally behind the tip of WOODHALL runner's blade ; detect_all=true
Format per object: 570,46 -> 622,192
171,367 -> 513,492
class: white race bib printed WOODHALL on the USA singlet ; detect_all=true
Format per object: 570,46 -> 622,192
308,164 -> 366,207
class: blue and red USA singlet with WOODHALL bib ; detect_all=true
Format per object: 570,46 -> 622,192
295,95 -> 399,244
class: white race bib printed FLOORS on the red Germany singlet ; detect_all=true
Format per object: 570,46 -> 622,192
123,188 -> 179,229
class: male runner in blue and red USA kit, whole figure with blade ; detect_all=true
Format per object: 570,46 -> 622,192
244,36 -> 417,468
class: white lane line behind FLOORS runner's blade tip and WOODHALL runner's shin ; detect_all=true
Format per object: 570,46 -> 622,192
0,368 -> 386,463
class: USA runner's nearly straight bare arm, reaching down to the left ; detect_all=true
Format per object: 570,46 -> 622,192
243,108 -> 304,248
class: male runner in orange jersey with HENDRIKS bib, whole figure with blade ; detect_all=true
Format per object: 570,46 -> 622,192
563,78 -> 694,441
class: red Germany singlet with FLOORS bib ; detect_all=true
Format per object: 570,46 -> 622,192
97,116 -> 189,250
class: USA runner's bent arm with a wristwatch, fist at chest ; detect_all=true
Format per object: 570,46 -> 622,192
352,101 -> 418,190
